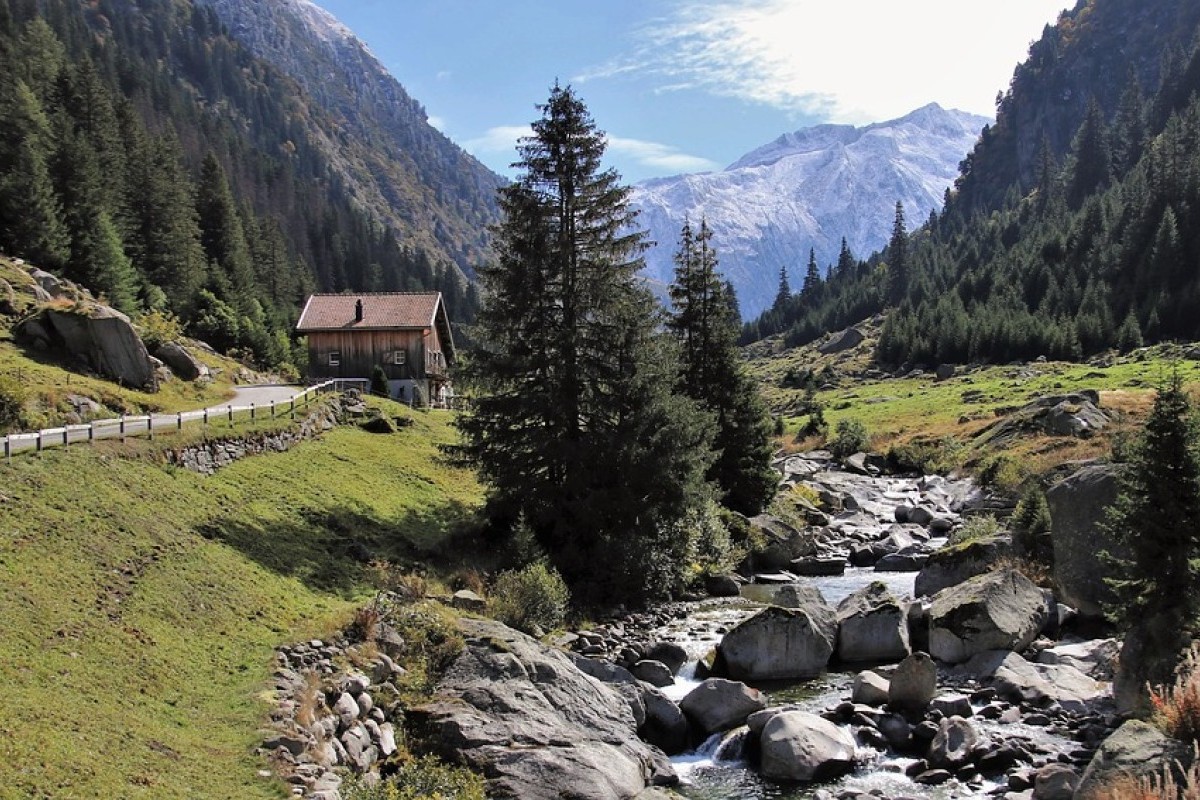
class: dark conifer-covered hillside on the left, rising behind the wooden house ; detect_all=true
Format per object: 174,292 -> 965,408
0,0 -> 492,366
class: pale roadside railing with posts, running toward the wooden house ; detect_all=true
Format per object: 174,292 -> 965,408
2,378 -> 371,459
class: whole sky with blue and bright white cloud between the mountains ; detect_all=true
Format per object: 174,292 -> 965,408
314,0 -> 1069,182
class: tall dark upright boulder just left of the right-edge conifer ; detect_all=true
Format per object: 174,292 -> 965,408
1046,464 -> 1129,619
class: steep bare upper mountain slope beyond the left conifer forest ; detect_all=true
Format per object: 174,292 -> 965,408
196,0 -> 502,273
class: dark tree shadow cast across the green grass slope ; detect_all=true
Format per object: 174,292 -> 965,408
199,501 -> 487,596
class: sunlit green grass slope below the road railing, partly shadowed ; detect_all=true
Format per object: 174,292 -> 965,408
0,407 -> 481,799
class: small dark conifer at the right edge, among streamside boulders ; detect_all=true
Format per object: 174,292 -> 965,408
1106,372 -> 1200,624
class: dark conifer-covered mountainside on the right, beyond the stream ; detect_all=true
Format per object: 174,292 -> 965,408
745,0 -> 1200,366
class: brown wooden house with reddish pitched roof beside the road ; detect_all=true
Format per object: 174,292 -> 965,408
296,291 -> 455,405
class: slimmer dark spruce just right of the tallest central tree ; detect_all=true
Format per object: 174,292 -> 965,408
667,218 -> 779,516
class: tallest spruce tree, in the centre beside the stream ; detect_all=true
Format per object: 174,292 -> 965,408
458,85 -> 712,604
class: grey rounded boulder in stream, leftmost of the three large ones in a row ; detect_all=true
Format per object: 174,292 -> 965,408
716,603 -> 838,680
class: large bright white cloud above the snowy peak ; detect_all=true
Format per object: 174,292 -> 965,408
575,0 -> 1068,122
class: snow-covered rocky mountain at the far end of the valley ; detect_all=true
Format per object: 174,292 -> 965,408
632,103 -> 989,318
